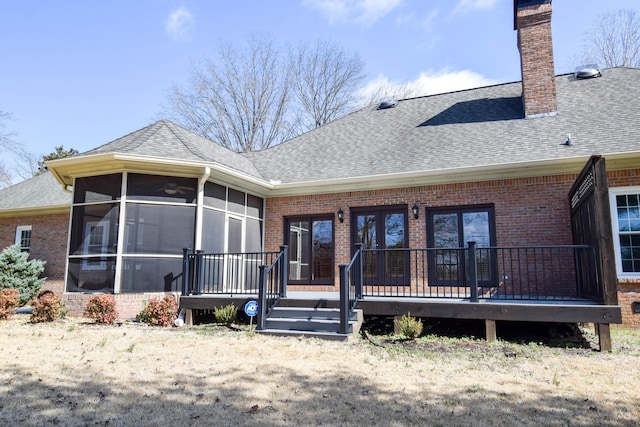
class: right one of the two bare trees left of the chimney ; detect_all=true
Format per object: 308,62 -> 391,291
291,40 -> 365,132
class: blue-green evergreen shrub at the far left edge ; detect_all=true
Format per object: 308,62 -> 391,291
0,245 -> 45,306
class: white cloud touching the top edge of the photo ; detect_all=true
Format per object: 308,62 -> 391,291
303,0 -> 402,27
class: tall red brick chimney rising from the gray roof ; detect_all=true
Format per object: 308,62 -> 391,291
514,0 -> 558,118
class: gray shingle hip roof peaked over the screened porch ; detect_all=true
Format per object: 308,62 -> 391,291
80,120 -> 261,178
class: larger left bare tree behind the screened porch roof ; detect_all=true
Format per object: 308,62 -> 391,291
166,36 -> 290,152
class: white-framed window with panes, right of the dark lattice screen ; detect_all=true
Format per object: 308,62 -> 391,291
609,187 -> 640,277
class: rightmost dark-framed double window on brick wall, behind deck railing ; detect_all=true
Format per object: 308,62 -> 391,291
427,206 -> 496,286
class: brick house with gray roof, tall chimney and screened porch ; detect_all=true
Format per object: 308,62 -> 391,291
0,0 -> 640,346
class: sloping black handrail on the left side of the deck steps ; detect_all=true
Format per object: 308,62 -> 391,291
256,246 -> 289,330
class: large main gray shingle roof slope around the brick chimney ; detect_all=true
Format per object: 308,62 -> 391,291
248,68 -> 640,183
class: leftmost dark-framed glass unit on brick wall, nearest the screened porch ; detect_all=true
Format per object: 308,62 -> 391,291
285,216 -> 334,284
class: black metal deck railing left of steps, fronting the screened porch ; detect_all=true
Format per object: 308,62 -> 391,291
182,249 -> 280,296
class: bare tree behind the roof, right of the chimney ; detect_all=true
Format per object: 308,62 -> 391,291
583,9 -> 640,67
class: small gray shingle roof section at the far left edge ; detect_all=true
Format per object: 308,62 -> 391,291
0,172 -> 71,210
